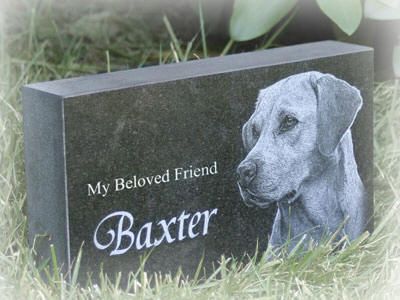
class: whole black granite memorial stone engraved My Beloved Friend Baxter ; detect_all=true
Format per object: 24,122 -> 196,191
23,41 -> 373,273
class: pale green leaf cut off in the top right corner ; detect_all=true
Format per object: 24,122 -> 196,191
364,0 -> 400,21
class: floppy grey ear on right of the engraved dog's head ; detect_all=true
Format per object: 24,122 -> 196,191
311,73 -> 362,156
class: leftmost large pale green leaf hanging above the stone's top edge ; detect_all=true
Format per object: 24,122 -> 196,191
229,0 -> 297,41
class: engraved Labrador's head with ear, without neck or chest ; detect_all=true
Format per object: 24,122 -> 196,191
237,72 -> 362,207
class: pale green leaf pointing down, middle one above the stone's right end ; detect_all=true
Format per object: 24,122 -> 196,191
317,0 -> 362,35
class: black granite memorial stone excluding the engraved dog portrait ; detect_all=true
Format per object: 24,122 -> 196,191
23,42 -> 373,273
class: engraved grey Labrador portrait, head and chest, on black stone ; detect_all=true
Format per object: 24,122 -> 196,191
237,72 -> 368,251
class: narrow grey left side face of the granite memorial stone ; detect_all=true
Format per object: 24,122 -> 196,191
22,88 -> 69,272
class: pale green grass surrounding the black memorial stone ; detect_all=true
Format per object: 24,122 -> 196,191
0,1 -> 400,299
